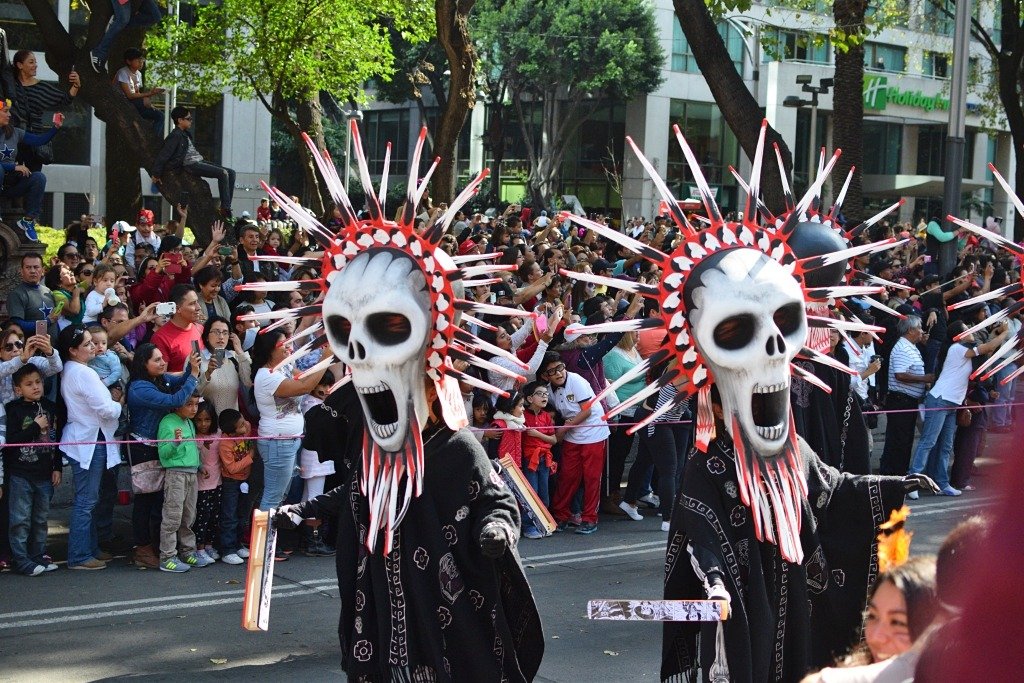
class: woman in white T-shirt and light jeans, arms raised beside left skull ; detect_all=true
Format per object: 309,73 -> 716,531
251,330 -> 326,518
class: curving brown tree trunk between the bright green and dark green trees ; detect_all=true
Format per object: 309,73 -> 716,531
431,0 -> 476,203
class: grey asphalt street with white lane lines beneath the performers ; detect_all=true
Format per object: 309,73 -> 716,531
0,475 -> 997,683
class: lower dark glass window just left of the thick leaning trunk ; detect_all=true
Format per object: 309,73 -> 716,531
666,99 -> 739,209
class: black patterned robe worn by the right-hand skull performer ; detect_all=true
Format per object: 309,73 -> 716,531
662,435 -> 903,683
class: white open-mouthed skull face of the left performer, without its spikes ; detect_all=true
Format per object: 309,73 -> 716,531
324,249 -> 431,453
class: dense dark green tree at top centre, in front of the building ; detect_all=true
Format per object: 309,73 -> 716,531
474,0 -> 665,208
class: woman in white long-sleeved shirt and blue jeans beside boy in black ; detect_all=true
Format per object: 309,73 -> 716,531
57,325 -> 121,569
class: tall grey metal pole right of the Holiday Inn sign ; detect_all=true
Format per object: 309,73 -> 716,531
938,0 -> 971,276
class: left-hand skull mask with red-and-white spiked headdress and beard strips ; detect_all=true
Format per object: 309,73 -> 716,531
240,121 -> 530,554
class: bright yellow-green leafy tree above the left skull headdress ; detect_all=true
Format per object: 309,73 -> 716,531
146,0 -> 433,213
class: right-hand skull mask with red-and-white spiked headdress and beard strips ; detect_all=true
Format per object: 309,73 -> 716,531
562,122 -> 898,562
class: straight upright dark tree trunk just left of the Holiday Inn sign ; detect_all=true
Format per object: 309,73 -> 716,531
831,0 -> 867,224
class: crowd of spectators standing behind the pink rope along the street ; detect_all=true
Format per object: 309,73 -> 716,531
0,201 -> 1020,574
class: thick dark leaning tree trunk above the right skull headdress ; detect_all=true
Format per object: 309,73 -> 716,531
673,0 -> 793,213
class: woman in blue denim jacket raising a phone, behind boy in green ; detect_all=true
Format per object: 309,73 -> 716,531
128,343 -> 200,568
